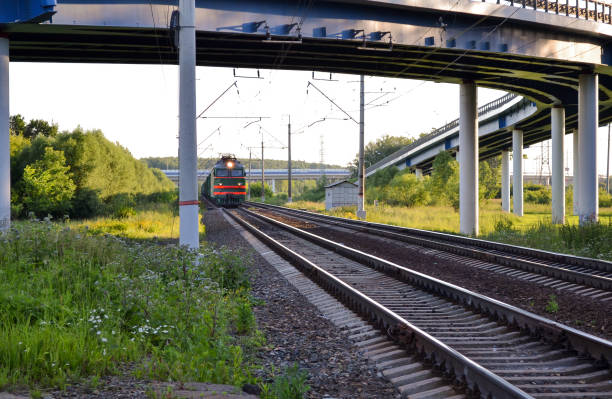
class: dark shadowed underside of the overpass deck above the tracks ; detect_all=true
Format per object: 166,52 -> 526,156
0,24 -> 612,166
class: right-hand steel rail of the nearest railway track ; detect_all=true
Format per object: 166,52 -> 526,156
241,209 -> 612,365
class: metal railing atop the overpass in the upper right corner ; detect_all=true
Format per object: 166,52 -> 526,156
473,0 -> 612,24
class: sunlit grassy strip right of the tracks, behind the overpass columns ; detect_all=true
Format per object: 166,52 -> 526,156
286,200 -> 612,260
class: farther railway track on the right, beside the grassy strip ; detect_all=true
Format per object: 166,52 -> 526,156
247,202 -> 612,301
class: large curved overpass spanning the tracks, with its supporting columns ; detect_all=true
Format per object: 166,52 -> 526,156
0,0 -> 612,247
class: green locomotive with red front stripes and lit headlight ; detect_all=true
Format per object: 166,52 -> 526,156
201,155 -> 247,207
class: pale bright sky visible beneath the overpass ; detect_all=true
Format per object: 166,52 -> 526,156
10,62 -> 607,174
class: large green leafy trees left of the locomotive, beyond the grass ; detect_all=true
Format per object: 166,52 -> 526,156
10,121 -> 175,222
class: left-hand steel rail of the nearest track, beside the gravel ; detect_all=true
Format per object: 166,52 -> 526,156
227,209 -> 533,399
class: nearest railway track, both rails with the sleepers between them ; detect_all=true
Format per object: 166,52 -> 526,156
231,209 -> 612,399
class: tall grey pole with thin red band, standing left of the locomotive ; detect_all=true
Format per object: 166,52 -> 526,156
179,0 -> 200,249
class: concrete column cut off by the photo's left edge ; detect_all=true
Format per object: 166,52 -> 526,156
0,37 -> 11,233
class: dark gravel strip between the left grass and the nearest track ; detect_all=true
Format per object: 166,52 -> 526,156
204,209 -> 399,398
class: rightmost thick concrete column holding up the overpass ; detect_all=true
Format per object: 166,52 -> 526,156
578,74 -> 599,225
